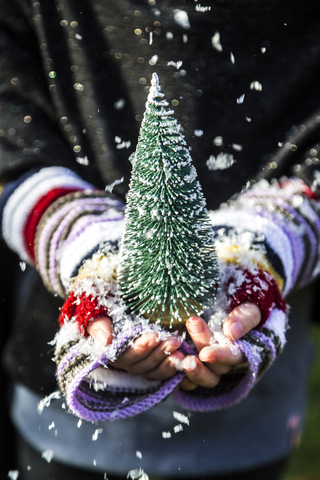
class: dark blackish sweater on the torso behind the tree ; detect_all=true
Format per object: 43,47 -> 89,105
0,0 -> 320,462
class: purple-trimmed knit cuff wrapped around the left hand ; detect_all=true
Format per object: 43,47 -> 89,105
56,325 -> 194,422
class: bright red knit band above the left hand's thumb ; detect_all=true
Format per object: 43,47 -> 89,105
59,292 -> 108,328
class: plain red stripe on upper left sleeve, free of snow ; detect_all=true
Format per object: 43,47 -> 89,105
22,187 -> 79,260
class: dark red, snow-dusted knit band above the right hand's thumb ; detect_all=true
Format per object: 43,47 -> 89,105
226,270 -> 287,328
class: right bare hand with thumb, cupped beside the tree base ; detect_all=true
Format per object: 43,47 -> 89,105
180,302 -> 261,390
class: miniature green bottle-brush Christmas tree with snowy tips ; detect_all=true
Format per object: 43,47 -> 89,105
119,73 -> 219,327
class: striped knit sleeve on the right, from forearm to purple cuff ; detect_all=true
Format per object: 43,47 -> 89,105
170,178 -> 320,411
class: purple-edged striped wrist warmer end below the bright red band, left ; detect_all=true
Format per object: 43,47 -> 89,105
55,321 -> 194,422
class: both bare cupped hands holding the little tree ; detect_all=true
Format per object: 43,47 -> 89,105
87,302 -> 261,390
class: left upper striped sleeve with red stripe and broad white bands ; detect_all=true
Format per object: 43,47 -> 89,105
0,167 -> 123,298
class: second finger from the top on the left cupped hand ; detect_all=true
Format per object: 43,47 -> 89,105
127,336 -> 181,375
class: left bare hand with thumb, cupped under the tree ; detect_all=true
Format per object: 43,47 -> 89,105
87,317 -> 184,380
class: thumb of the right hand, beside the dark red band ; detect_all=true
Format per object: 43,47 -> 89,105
223,302 -> 261,342
